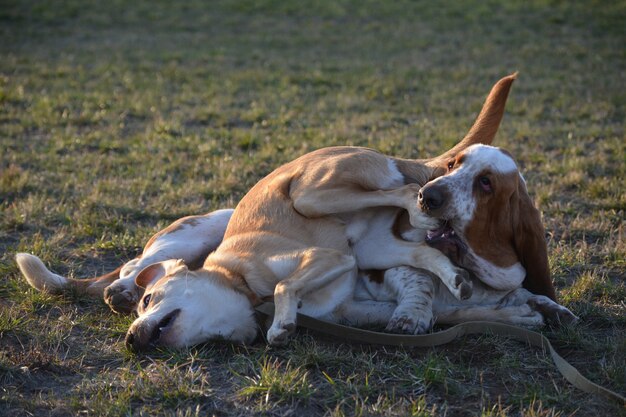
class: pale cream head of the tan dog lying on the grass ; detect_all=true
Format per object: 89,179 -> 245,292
126,260 -> 257,351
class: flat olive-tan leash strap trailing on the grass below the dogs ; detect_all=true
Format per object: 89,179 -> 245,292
256,303 -> 626,407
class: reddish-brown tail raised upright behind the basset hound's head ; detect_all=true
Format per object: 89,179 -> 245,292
426,72 -> 517,171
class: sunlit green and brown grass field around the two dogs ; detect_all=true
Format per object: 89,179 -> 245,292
0,0 -> 626,416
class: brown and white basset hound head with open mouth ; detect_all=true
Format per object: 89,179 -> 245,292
418,145 -> 555,299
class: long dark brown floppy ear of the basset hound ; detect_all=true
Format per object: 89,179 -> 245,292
511,178 -> 556,301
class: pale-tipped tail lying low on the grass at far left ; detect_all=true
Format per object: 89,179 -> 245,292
15,253 -> 122,297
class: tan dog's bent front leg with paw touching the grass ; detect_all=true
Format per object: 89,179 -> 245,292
267,247 -> 356,345
